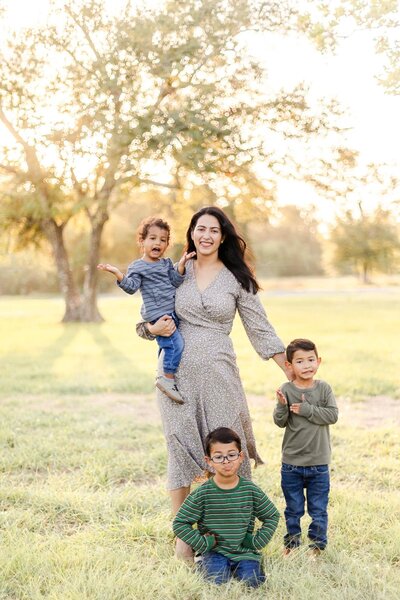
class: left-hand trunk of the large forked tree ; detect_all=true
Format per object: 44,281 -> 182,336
43,220 -> 81,323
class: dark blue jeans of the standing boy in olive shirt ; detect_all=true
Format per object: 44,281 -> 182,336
281,463 -> 329,550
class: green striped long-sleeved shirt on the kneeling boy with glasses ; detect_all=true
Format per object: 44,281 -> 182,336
173,477 -> 279,560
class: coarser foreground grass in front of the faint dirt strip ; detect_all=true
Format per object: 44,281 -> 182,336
0,395 -> 400,600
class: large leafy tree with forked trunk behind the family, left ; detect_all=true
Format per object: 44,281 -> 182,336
0,0 -> 344,321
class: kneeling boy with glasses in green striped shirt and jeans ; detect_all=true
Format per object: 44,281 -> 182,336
173,427 -> 279,587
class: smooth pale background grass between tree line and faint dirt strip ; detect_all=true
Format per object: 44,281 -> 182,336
0,292 -> 400,398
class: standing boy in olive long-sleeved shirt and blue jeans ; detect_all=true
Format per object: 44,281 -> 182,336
274,339 -> 338,554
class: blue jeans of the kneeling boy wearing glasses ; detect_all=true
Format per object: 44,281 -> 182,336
200,551 -> 265,587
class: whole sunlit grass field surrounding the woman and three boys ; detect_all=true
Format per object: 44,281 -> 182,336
0,291 -> 400,600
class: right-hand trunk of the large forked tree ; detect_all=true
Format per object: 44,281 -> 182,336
81,215 -> 108,323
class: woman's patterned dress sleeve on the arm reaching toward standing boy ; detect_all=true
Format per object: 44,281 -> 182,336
236,286 -> 285,360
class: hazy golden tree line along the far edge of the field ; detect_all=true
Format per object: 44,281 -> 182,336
0,190 -> 400,294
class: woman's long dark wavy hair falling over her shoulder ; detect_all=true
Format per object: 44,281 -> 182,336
186,206 -> 260,294
